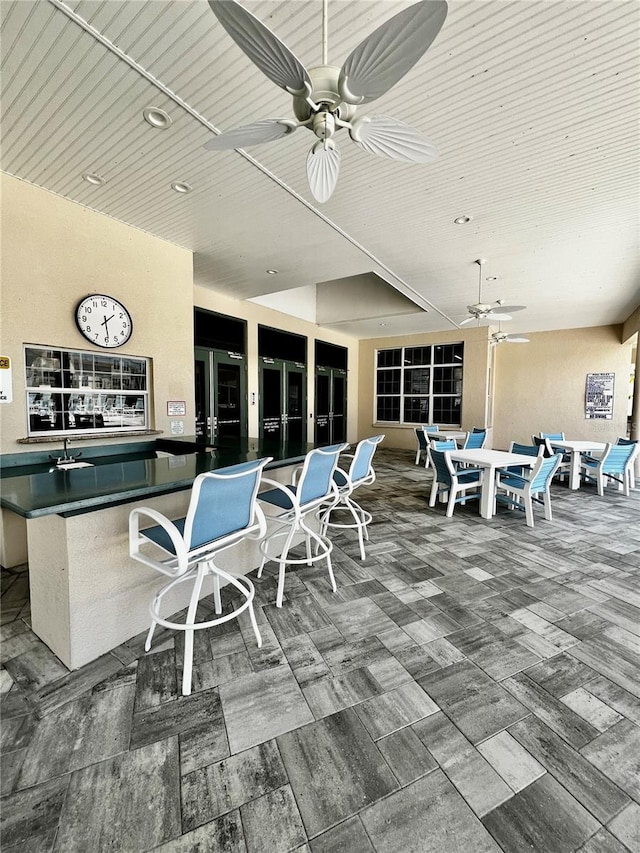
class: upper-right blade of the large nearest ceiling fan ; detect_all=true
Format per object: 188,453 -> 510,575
338,0 -> 447,104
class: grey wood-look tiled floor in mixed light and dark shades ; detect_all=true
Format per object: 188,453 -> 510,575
0,450 -> 640,853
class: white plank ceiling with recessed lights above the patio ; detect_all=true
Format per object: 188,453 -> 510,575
0,0 -> 640,337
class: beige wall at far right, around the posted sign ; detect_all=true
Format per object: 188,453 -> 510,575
492,326 -> 632,448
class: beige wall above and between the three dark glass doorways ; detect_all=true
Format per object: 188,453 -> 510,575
193,286 -> 359,441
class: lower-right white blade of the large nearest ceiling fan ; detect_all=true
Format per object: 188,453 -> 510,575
349,116 -> 438,163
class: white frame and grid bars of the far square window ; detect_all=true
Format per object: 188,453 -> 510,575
373,341 -> 464,427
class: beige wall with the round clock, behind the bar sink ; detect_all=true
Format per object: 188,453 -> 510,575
0,175 -> 195,453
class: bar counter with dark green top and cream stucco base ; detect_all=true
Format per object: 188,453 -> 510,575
0,438 -> 320,669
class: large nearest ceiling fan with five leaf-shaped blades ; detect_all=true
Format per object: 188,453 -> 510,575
204,0 -> 447,202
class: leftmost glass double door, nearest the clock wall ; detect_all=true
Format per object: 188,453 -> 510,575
195,347 -> 247,443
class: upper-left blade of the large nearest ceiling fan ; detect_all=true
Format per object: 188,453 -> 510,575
209,0 -> 313,96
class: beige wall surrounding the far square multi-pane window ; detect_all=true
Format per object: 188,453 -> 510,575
358,327 -> 492,449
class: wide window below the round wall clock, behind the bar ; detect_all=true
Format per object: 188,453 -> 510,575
25,347 -> 149,435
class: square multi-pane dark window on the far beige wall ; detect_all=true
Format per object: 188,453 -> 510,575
376,343 -> 464,426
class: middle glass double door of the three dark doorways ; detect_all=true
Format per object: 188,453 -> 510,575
259,358 -> 307,441
